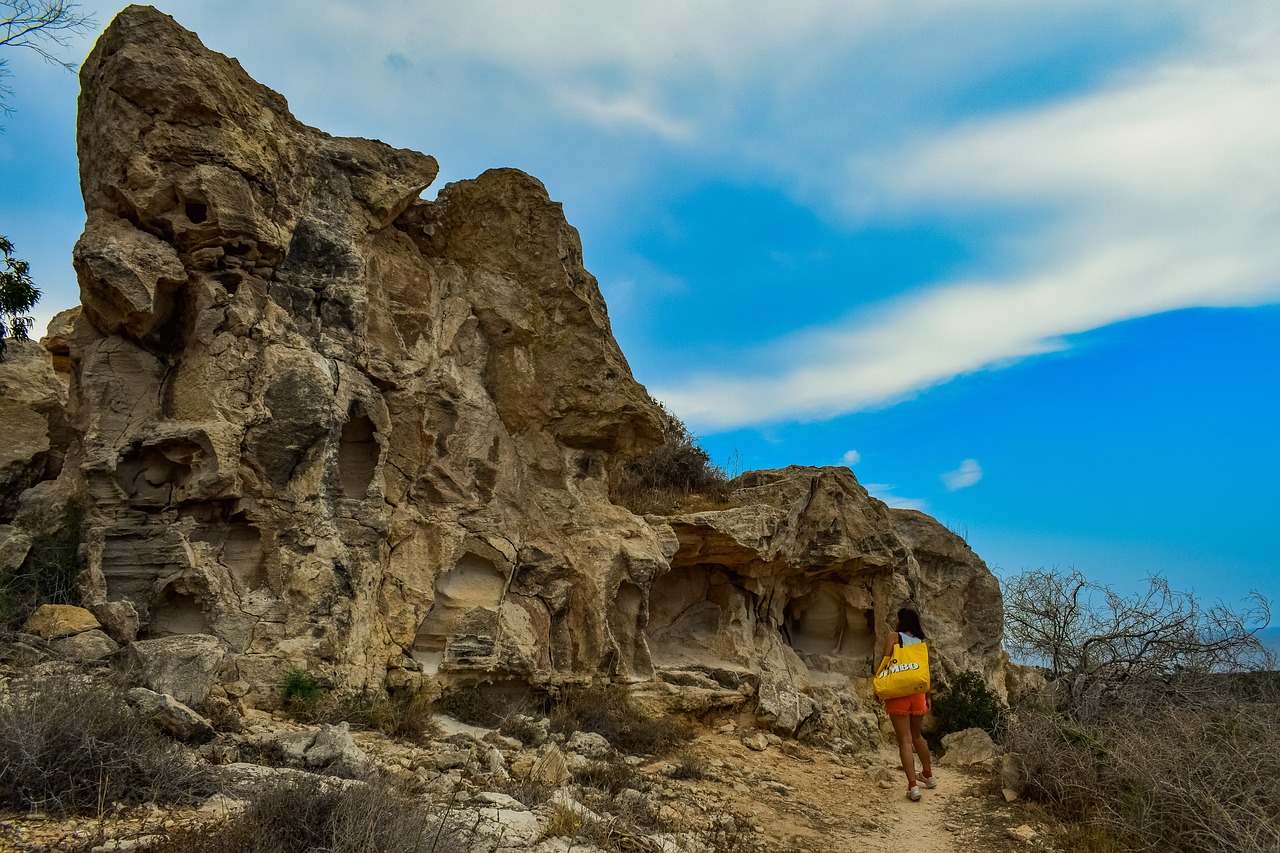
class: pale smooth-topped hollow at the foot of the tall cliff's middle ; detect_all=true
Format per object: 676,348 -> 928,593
413,553 -> 507,675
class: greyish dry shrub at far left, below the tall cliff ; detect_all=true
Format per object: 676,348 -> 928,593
0,679 -> 214,815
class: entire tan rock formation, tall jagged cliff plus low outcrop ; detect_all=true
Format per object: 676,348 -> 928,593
0,6 -> 1001,730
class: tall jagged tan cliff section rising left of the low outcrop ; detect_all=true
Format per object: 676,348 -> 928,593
70,6 -> 664,702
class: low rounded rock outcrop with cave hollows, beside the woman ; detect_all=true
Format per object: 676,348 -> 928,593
644,466 -> 1002,731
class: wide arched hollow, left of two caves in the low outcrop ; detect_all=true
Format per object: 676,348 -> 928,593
645,565 -> 755,665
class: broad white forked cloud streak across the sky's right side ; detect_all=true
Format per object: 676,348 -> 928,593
658,6 -> 1280,429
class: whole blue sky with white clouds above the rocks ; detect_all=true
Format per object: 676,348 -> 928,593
0,0 -> 1280,630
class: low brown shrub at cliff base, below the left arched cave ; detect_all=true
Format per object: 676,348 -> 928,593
550,686 -> 694,756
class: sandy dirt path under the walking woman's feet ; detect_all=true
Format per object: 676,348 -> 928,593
670,733 -> 1047,853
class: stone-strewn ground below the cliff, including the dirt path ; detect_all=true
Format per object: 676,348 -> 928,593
0,660 -> 1055,853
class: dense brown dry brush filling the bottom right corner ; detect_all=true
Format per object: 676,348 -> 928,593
1006,675 -> 1280,853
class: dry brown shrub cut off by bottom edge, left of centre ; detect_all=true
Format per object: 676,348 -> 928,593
154,777 -> 467,853
